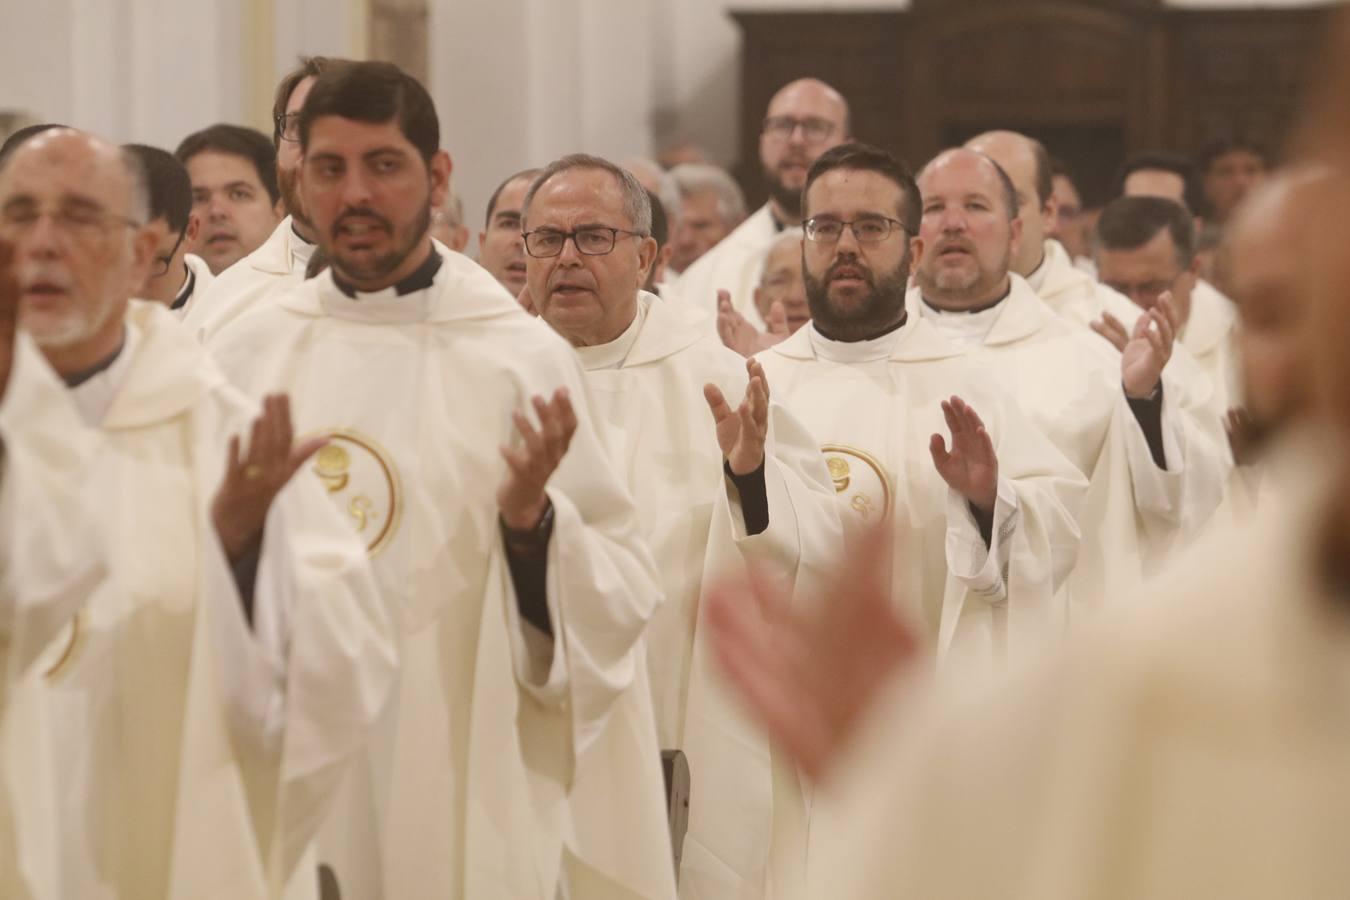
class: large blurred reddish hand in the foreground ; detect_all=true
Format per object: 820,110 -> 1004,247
707,524 -> 919,779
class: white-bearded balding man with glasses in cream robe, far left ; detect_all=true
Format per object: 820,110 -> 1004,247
0,130 -> 397,899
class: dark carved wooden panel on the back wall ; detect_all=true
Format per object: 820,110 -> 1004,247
733,0 -> 1328,207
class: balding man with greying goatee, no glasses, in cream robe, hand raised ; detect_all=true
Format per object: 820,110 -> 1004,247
906,148 -> 1229,591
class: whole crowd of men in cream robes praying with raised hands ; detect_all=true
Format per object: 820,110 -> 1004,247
0,35 -> 1350,900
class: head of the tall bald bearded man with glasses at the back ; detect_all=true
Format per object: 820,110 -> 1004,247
760,78 -> 852,225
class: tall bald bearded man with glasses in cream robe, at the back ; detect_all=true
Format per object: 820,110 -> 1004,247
672,78 -> 851,331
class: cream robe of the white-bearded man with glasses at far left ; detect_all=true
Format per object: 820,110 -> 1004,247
7,301 -> 397,900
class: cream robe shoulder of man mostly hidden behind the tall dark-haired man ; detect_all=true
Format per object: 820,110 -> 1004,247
182,216 -> 316,341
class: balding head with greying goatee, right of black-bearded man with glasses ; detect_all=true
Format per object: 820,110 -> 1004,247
914,148 -> 1022,310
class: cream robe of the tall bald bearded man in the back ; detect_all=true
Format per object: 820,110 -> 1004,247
662,204 -> 779,331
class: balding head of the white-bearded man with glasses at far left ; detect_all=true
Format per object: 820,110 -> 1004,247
0,128 -> 155,374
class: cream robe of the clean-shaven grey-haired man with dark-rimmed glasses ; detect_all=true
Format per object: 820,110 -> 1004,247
578,294 -> 844,899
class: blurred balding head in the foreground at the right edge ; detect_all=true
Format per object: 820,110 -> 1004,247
1220,167 -> 1341,437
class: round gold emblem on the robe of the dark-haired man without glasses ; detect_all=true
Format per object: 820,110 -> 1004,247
313,428 -> 404,556
